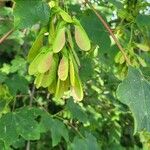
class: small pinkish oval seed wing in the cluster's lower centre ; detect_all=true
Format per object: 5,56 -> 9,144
58,55 -> 69,81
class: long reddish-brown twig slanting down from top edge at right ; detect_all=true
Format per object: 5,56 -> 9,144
85,0 -> 131,65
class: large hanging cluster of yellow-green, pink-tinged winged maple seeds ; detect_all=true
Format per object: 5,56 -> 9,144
28,7 -> 91,101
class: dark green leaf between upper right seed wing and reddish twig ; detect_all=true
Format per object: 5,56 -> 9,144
80,10 -> 111,53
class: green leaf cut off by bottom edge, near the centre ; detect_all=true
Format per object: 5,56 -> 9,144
71,133 -> 100,150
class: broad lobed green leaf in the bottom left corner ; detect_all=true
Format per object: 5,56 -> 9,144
0,107 -> 45,146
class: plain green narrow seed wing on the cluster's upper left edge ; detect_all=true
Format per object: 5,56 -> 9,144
27,27 -> 47,62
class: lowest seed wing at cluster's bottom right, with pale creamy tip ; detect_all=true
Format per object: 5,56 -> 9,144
71,75 -> 83,101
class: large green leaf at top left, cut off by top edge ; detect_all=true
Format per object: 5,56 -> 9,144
14,0 -> 50,29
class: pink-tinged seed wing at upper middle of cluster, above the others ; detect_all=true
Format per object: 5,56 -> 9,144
53,27 -> 66,53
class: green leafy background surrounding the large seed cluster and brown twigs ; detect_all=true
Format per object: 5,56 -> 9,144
0,0 -> 150,150
